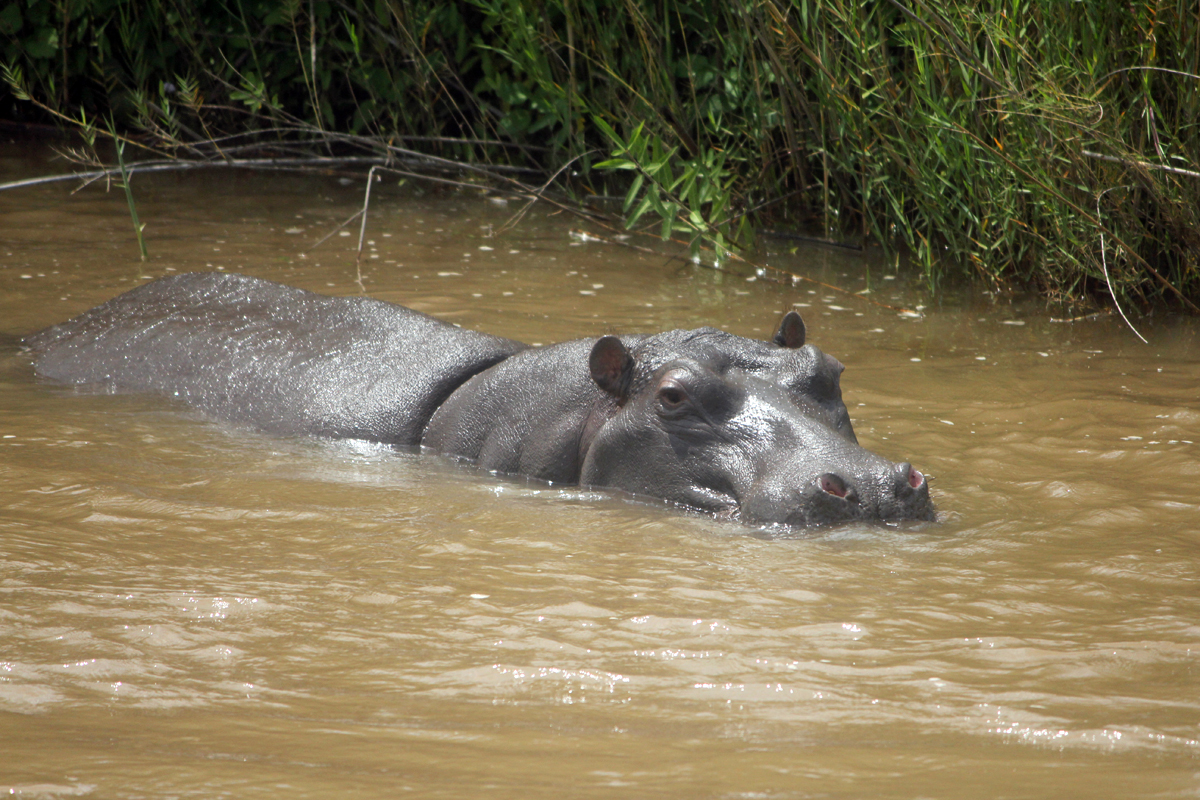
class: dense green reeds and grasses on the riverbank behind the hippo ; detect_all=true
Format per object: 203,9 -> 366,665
0,0 -> 1200,312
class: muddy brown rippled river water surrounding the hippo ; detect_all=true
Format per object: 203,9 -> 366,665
0,145 -> 1200,798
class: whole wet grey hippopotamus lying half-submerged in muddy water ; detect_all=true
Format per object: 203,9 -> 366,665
25,272 -> 935,527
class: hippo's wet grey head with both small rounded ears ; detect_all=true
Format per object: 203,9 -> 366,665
581,315 -> 934,525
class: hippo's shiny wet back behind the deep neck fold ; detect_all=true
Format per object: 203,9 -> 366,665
26,272 -> 526,445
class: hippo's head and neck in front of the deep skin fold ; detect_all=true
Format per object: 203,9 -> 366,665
422,318 -> 934,525
